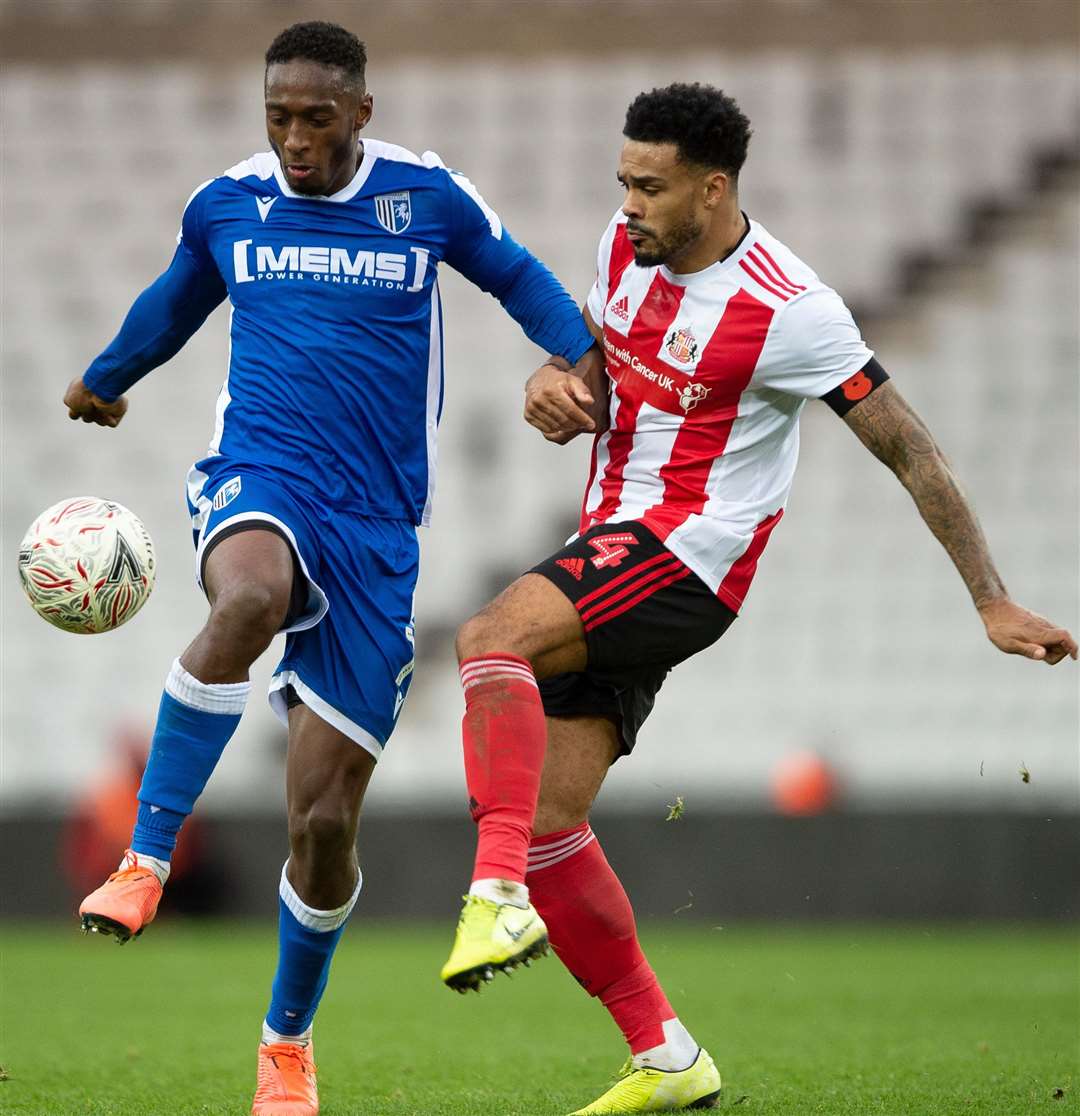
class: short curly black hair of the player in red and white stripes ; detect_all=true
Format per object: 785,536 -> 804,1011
623,81 -> 751,180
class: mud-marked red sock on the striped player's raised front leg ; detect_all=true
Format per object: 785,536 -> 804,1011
461,653 -> 548,884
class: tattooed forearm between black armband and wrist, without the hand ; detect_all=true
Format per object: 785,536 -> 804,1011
845,383 -> 1005,608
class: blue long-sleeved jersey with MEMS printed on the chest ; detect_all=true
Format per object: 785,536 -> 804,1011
84,140 -> 592,523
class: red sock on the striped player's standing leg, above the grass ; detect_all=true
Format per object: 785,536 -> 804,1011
527,821 -> 675,1054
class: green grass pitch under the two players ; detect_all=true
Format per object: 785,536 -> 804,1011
0,913 -> 1080,1116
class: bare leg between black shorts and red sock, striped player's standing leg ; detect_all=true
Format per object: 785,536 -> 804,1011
532,716 -> 621,837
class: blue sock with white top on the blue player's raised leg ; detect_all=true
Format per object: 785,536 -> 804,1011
132,658 -> 251,860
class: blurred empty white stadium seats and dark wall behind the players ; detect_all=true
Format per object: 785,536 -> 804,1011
0,0 -> 1080,918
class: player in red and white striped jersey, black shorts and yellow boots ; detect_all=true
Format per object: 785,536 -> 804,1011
442,85 -> 1077,1114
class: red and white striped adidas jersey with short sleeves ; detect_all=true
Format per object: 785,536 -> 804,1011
580,213 -> 874,612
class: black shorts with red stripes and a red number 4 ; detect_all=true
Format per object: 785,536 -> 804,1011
530,520 -> 735,756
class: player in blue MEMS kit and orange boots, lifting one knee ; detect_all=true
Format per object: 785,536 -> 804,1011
64,22 -> 598,1116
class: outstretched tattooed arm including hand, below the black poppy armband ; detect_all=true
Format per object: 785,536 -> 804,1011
845,382 -> 1077,666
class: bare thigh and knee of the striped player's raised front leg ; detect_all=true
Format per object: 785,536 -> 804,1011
457,573 -> 586,679
